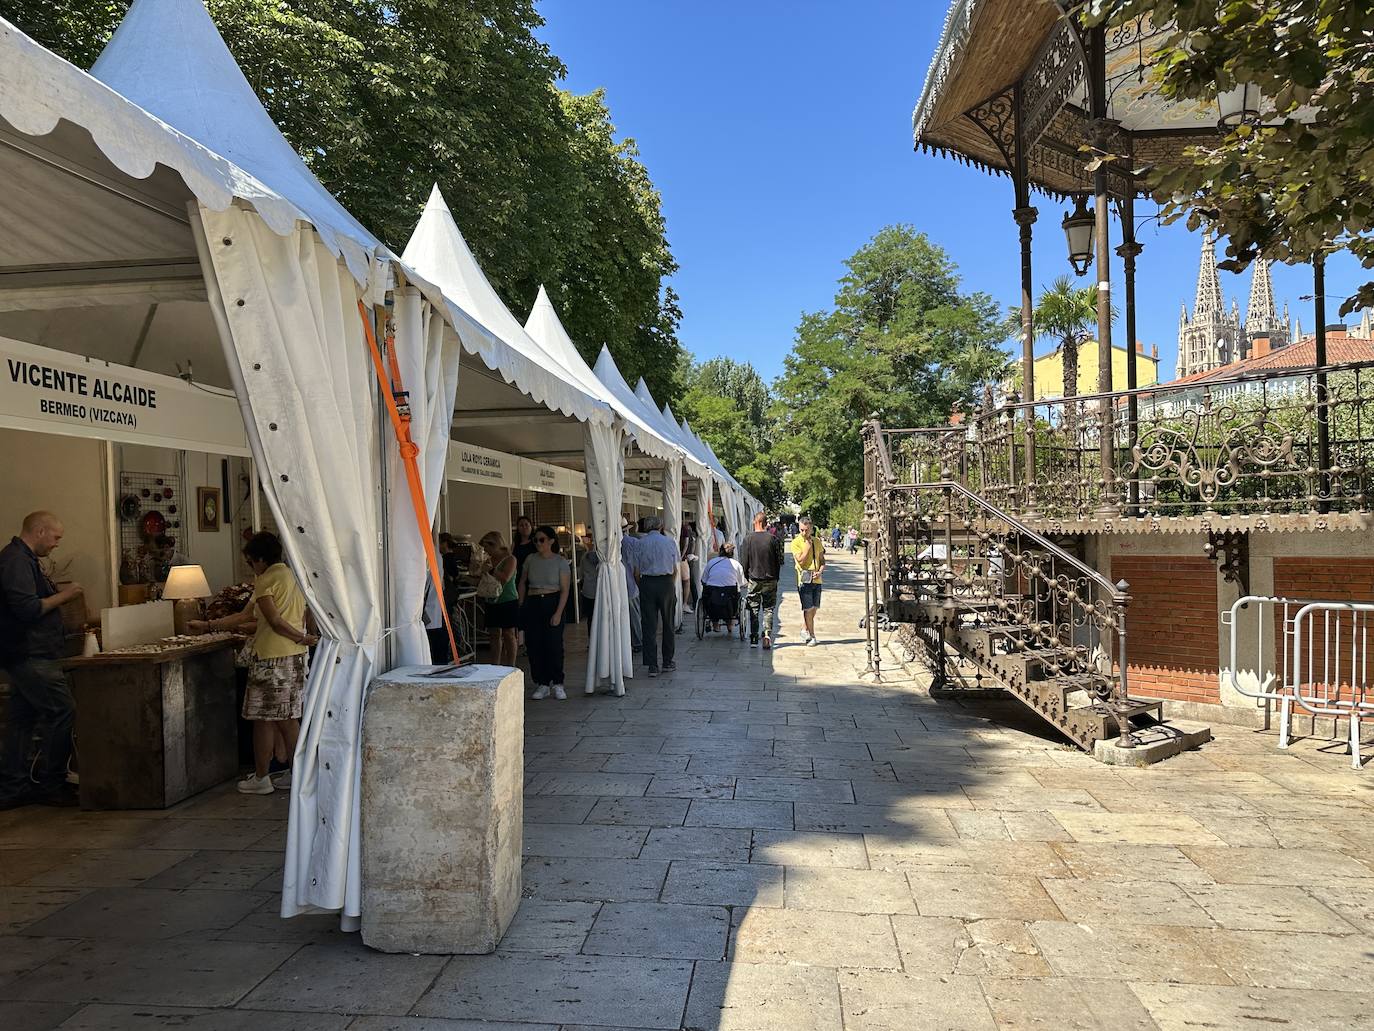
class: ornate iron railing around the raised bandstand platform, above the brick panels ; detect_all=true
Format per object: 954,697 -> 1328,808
879,363 -> 1374,520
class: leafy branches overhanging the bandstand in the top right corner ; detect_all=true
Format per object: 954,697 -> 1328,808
1083,0 -> 1374,315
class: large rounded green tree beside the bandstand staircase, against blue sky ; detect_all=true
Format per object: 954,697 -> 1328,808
774,225 -> 1011,521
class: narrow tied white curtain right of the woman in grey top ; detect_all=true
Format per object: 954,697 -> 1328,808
583,422 -> 633,694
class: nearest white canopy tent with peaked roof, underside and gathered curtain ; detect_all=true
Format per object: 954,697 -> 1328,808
0,0 -> 471,924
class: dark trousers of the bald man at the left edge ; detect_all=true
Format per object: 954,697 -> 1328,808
0,658 -> 77,800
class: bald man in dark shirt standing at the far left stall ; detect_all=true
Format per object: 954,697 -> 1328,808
0,511 -> 81,808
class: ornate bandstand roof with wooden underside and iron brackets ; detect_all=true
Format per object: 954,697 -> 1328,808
912,0 -> 1217,197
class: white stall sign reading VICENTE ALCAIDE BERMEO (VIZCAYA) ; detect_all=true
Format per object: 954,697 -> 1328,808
0,337 -> 249,456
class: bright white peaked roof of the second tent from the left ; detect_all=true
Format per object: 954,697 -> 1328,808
401,186 -> 611,422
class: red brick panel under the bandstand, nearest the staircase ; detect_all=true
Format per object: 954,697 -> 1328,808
1112,554 -> 1220,704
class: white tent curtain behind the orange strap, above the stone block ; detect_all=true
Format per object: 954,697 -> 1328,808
385,286 -> 460,665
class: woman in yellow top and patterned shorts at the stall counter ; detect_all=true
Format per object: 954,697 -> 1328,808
191,533 -> 319,795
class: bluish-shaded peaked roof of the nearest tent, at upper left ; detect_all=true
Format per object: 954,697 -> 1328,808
84,0 -> 385,282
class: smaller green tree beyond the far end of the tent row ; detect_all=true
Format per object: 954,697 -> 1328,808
679,357 -> 785,510
